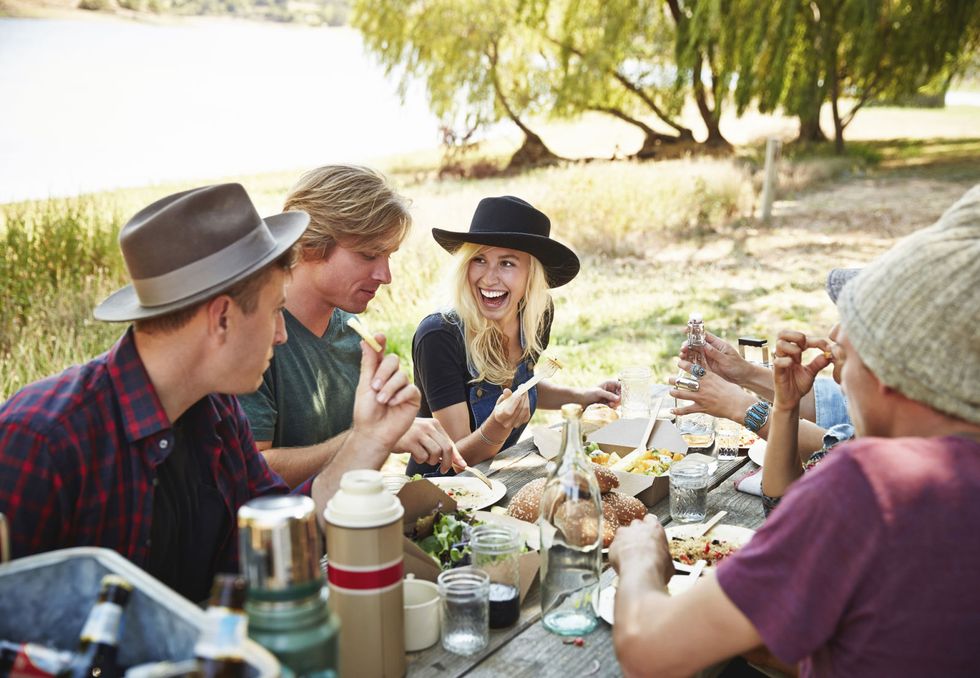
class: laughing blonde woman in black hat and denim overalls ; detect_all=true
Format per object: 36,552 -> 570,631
408,196 -> 619,475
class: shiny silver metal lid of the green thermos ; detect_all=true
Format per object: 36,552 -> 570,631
238,495 -> 321,591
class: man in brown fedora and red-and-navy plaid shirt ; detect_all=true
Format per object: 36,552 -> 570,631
0,184 -> 419,600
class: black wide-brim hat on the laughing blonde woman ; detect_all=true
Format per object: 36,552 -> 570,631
432,195 -> 581,287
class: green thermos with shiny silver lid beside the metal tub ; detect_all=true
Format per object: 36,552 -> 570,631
238,495 -> 339,678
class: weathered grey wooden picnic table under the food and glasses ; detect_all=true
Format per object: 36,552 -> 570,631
408,439 -> 764,678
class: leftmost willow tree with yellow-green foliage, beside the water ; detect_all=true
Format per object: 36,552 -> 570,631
351,0 -> 557,166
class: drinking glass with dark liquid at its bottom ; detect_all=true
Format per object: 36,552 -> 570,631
470,525 -> 523,629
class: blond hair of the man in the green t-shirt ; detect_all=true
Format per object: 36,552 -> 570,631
283,165 -> 412,261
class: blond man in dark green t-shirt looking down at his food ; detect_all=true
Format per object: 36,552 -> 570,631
241,165 -> 465,487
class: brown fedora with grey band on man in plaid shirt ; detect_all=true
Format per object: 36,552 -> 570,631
95,184 -> 310,322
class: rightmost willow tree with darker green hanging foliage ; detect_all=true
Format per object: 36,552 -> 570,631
727,0 -> 980,152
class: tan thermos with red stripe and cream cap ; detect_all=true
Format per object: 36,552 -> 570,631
323,470 -> 405,678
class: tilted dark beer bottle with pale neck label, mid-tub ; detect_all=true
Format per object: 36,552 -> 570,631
69,574 -> 133,678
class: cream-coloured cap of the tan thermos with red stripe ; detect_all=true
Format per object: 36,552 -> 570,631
323,469 -> 405,528
